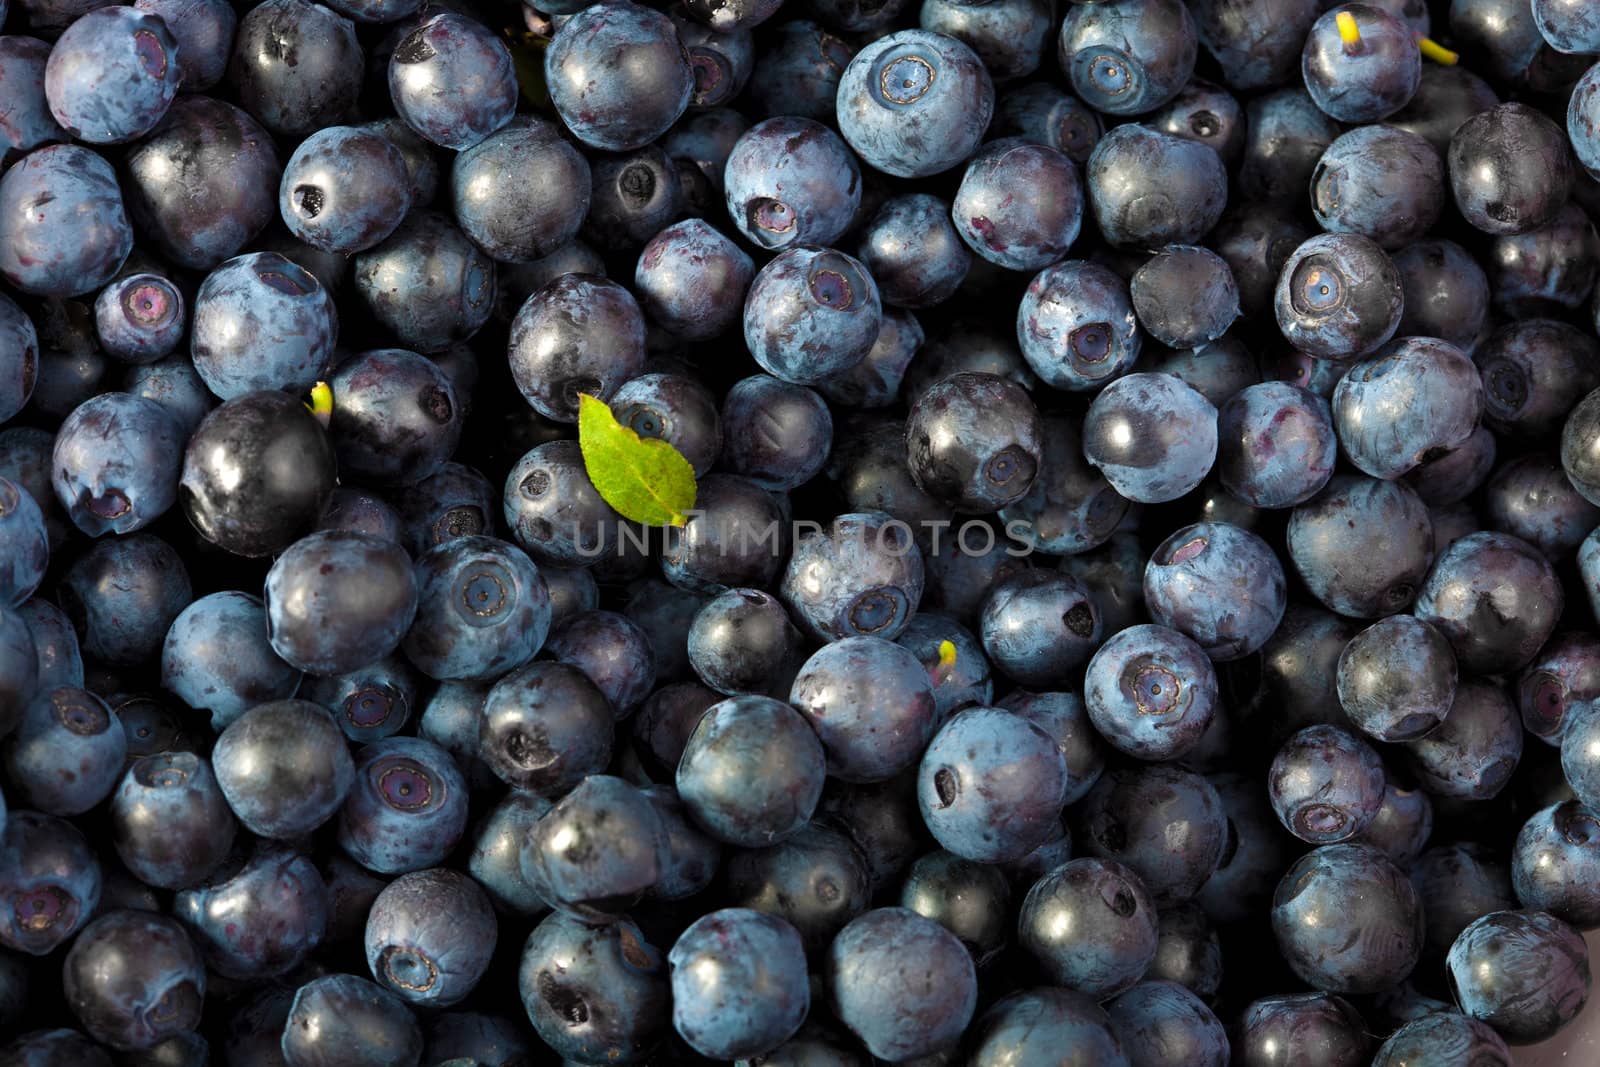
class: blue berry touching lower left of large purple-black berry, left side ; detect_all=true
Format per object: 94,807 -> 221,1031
162,592 -> 301,729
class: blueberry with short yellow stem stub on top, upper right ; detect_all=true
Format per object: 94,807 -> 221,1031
1301,3 -> 1422,123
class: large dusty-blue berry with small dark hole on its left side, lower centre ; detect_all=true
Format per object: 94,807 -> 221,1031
917,707 -> 1067,864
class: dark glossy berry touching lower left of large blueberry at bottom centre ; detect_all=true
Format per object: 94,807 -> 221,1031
522,774 -> 672,923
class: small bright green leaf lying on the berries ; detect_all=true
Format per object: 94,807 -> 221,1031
578,394 -> 694,526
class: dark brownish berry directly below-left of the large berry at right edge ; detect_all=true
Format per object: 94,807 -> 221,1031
1338,614 -> 1456,741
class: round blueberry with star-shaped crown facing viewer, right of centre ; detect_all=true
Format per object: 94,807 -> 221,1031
1083,625 -> 1219,760
